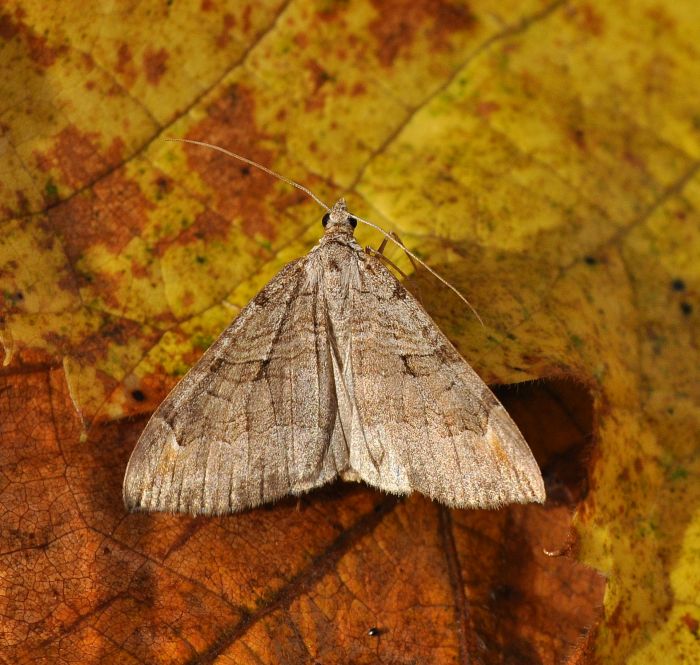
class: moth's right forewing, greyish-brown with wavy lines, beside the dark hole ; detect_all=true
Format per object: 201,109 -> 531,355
350,257 -> 545,508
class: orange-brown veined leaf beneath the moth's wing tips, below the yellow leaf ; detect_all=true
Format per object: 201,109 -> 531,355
0,369 -> 603,663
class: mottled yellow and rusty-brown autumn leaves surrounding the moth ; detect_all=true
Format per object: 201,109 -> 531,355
0,0 -> 700,665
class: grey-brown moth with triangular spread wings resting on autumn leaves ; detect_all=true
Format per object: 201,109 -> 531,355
123,139 -> 545,515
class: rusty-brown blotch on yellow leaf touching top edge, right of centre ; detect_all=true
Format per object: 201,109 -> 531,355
369,0 -> 476,67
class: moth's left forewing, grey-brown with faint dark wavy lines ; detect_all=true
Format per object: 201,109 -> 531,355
124,257 -> 347,514
